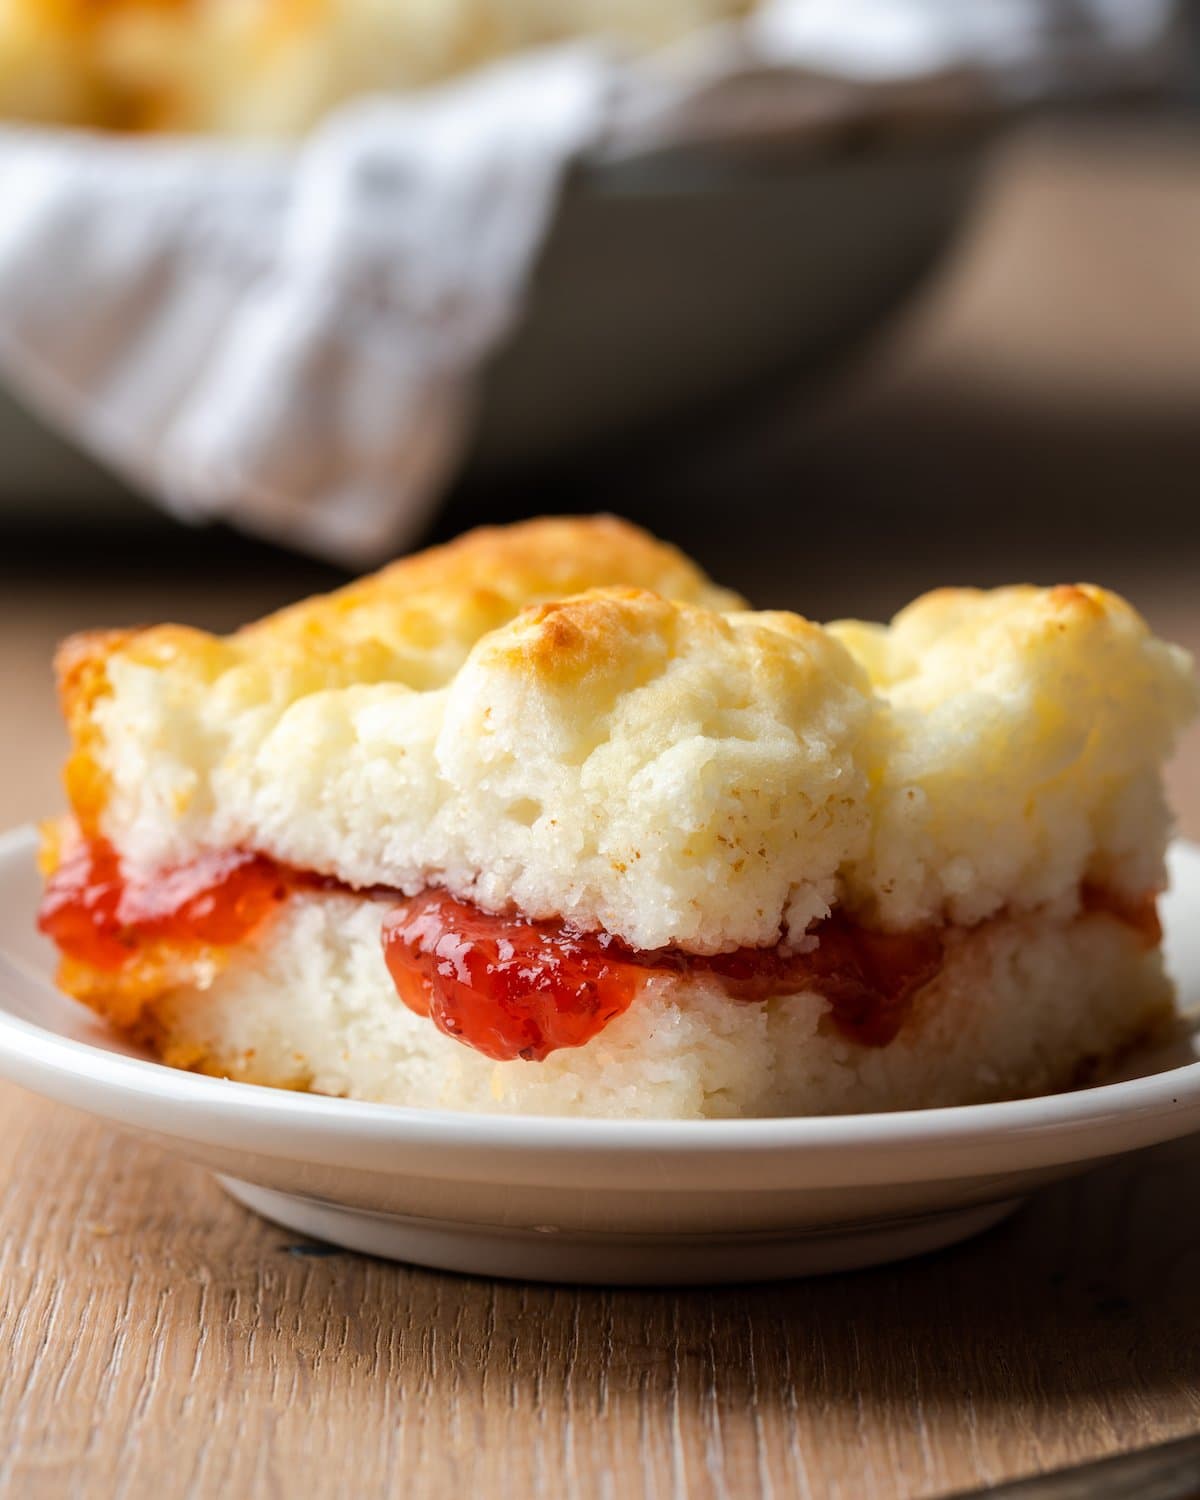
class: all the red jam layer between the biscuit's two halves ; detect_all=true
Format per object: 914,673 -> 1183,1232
38,840 -> 1161,1062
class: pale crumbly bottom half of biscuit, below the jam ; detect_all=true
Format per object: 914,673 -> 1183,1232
96,890 -> 1172,1119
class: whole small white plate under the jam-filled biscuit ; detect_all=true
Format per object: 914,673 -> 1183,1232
0,830 -> 1200,1283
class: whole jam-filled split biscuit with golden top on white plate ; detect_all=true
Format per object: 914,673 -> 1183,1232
44,518 -> 1196,1118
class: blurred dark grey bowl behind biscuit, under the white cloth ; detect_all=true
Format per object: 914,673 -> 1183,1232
0,131 -> 987,522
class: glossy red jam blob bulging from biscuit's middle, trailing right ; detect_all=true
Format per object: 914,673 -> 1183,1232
384,891 -> 942,1062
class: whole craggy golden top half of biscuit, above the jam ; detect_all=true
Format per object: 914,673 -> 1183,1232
51,518 -> 1196,953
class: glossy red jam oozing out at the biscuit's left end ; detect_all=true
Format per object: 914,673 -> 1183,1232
38,840 -> 294,969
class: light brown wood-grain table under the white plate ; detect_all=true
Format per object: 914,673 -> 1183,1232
0,129 -> 1200,1500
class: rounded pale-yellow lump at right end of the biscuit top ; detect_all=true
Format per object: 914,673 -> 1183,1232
830,584 -> 1196,927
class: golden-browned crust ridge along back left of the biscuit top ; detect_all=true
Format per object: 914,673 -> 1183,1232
63,516 -> 743,833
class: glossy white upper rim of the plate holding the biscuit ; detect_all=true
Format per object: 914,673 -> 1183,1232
0,824 -> 1200,1157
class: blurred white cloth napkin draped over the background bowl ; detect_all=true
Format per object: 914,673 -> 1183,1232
0,0 -> 1173,566
